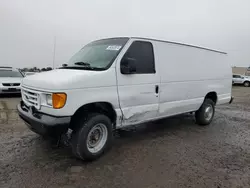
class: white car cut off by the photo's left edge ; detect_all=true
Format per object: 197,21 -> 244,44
0,67 -> 23,94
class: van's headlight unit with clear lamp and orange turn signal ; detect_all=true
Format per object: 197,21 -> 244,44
45,93 -> 67,109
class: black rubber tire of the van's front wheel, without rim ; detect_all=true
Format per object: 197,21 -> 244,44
71,113 -> 113,161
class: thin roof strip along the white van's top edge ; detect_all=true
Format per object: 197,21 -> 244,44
98,37 -> 227,54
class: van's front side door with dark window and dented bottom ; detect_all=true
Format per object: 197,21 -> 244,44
116,40 -> 160,126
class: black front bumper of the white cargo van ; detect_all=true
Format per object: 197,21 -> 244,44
17,101 -> 71,136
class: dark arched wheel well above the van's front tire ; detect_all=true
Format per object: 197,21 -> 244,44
70,102 -> 117,129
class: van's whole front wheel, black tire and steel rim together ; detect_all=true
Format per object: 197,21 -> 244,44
72,113 -> 113,160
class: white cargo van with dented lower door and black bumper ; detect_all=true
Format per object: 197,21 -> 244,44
18,37 -> 233,160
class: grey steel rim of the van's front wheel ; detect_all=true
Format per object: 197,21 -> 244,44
87,123 -> 108,153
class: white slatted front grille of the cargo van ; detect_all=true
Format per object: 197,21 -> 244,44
22,88 -> 40,109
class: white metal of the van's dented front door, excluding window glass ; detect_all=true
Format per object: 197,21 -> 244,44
116,39 -> 160,128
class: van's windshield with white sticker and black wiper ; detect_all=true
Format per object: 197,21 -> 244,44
61,38 -> 128,70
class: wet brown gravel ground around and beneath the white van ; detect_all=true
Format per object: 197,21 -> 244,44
0,87 -> 250,188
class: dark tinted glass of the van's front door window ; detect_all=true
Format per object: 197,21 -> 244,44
123,41 -> 155,74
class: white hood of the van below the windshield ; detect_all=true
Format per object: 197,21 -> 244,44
22,68 -> 116,91
